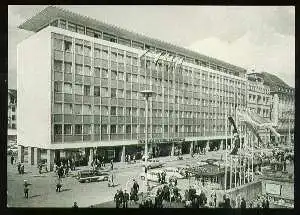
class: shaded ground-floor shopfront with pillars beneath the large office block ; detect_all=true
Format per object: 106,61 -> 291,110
18,137 -> 243,170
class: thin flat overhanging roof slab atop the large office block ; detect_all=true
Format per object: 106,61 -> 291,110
19,6 -> 247,73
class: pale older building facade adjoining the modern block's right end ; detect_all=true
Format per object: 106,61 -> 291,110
247,73 -> 272,143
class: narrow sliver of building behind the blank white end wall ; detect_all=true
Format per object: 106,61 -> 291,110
7,89 -> 17,141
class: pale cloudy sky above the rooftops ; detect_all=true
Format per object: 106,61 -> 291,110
8,5 -> 295,89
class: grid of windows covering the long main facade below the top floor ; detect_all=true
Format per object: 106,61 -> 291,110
52,33 -> 246,142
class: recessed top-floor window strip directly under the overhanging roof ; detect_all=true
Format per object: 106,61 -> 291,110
50,19 -> 245,77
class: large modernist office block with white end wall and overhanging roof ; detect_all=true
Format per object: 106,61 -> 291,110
18,6 -> 247,169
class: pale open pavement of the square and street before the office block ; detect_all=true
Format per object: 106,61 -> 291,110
7,151 -> 227,207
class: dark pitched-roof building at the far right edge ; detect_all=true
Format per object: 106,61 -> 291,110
261,72 -> 295,143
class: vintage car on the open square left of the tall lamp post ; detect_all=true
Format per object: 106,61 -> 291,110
77,170 -> 109,183
